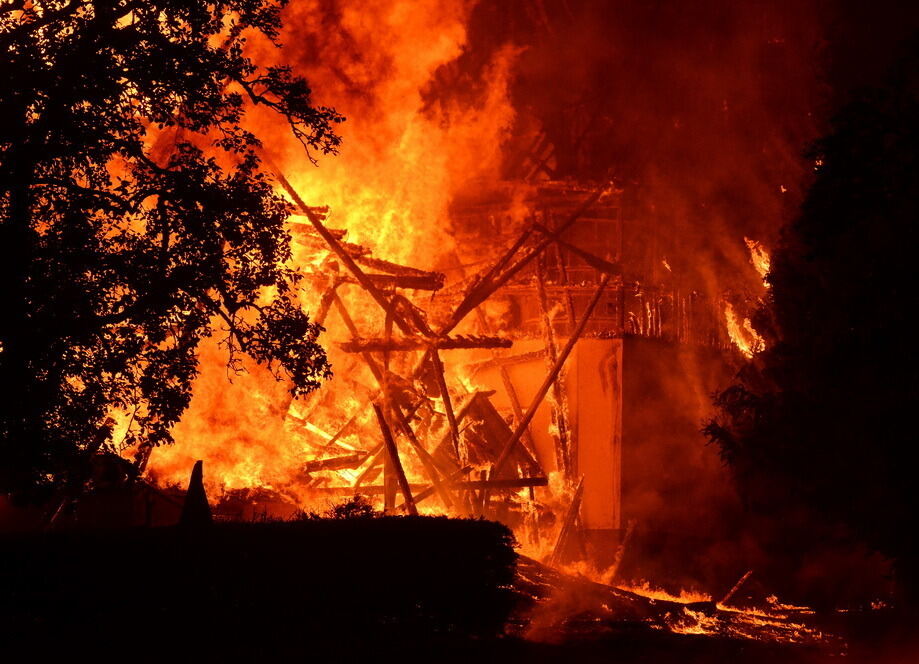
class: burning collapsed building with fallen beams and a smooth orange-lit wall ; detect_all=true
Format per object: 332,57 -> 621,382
127,169 -> 731,563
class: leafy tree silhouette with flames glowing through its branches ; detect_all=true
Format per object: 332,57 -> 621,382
0,0 -> 342,492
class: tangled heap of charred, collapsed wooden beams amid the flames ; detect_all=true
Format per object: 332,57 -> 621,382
279,174 -> 618,529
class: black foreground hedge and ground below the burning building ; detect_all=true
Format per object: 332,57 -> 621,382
0,517 -> 919,664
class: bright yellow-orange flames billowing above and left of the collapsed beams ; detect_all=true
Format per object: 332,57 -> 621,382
141,0 -> 515,508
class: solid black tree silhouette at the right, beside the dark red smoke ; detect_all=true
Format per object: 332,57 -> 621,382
706,41 -> 919,600
